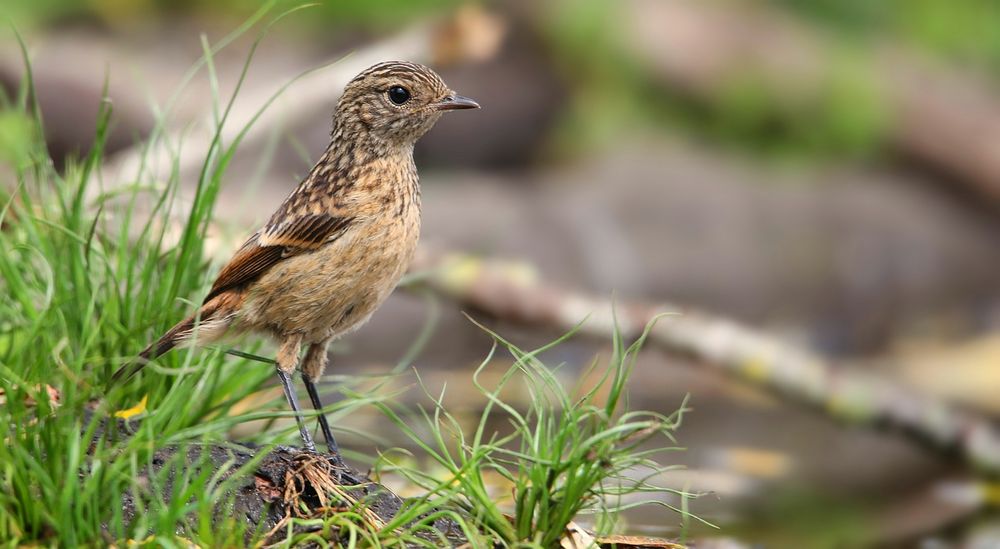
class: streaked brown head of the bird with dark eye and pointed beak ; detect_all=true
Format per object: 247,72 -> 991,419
335,61 -> 479,146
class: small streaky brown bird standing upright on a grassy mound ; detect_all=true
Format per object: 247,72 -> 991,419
112,61 -> 480,453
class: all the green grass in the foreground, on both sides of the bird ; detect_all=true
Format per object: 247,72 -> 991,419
0,5 -> 687,547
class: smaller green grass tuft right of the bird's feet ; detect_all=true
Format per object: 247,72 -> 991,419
375,314 -> 692,547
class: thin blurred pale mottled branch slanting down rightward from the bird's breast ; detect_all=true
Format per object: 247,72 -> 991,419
412,251 -> 1000,473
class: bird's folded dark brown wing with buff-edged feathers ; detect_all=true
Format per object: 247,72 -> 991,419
204,214 -> 354,303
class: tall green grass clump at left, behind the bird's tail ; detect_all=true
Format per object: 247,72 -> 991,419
0,8 -> 318,547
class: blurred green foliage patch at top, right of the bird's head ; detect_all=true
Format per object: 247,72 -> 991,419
542,0 -> 889,161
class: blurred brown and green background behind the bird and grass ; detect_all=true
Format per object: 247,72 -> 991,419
0,0 -> 1000,548
